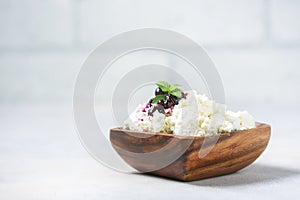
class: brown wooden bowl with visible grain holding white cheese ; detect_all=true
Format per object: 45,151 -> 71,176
110,123 -> 271,181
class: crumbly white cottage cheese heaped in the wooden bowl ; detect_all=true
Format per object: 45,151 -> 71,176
123,91 -> 255,136
